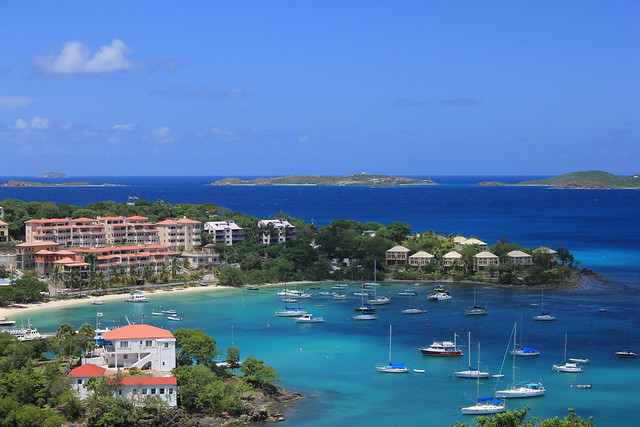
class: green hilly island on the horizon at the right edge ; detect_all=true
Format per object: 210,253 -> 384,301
478,171 -> 640,189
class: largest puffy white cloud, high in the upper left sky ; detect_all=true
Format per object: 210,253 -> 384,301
35,39 -> 133,75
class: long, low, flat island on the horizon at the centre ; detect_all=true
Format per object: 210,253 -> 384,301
211,172 -> 435,186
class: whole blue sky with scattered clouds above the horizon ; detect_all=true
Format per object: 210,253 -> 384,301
0,0 -> 640,176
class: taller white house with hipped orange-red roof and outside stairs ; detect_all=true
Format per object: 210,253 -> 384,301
102,325 -> 176,372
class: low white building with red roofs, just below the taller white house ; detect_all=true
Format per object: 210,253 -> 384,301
68,363 -> 178,406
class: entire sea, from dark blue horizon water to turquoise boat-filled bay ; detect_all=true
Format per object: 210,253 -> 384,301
0,176 -> 640,426
